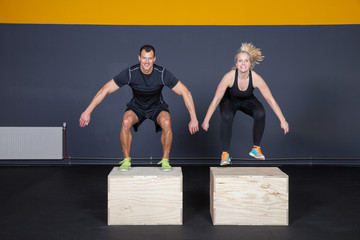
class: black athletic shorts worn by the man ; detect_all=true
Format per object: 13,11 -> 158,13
125,102 -> 170,132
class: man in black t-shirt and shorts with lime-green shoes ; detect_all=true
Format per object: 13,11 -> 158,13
79,45 -> 199,171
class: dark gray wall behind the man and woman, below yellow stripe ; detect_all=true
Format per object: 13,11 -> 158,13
0,24 -> 360,158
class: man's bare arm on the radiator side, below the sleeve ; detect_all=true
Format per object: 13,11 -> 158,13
79,79 -> 119,127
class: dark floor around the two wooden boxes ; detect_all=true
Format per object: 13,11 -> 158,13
0,166 -> 360,240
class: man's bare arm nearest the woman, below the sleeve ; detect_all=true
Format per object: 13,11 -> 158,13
172,81 -> 199,134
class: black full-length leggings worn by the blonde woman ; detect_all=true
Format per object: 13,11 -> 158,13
220,96 -> 265,152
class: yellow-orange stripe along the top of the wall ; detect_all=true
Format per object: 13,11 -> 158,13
0,0 -> 360,25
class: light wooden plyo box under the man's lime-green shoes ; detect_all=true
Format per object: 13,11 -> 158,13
108,167 -> 183,225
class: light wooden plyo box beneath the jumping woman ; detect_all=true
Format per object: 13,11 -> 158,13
210,167 -> 289,225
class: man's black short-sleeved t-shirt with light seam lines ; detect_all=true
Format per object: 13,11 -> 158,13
113,63 -> 179,109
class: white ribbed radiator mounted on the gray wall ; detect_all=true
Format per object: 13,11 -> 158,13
0,127 -> 63,159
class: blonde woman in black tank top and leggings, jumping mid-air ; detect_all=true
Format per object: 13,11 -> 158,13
201,43 -> 289,166
